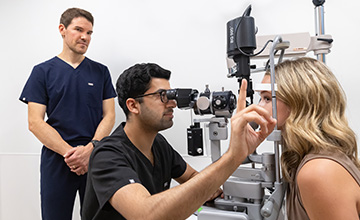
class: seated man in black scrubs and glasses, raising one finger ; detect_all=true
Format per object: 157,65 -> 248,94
82,63 -> 276,220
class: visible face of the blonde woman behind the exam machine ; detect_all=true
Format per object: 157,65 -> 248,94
259,75 -> 290,130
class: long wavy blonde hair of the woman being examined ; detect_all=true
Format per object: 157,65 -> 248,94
266,57 -> 360,182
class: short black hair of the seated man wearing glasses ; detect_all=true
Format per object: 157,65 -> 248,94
116,63 -> 171,117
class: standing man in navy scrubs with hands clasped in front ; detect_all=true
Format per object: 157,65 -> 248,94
20,8 -> 116,220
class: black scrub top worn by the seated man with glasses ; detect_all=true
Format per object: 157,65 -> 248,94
82,123 -> 186,220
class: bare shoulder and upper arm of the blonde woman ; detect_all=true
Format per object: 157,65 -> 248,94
296,158 -> 360,217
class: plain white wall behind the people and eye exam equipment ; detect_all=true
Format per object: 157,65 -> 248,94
0,0 -> 360,220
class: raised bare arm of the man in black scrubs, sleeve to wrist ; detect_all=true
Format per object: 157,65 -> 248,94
110,151 -> 240,219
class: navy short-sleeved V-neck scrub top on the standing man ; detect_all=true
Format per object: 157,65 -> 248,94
20,57 -> 116,146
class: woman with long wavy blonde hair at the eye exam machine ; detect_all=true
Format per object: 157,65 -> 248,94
259,57 -> 360,220
